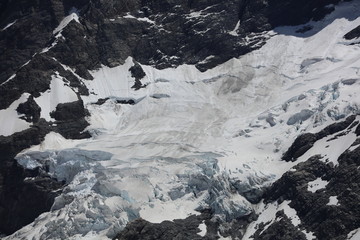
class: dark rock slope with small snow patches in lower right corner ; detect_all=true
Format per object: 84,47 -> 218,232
254,116 -> 360,240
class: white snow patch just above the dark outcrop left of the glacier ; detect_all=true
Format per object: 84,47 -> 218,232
34,74 -> 78,121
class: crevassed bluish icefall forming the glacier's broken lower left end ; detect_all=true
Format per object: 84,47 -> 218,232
13,149 -> 251,239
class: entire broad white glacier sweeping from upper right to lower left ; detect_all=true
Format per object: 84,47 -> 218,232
5,1 -> 360,239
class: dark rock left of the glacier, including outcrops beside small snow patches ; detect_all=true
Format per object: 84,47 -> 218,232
0,97 -> 90,234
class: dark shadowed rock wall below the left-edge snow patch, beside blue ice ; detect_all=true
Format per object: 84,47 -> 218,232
0,121 -> 62,234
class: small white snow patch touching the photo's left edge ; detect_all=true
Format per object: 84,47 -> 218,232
0,93 -> 30,136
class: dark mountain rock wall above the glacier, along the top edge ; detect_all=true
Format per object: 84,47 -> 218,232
0,0 -> 344,109
